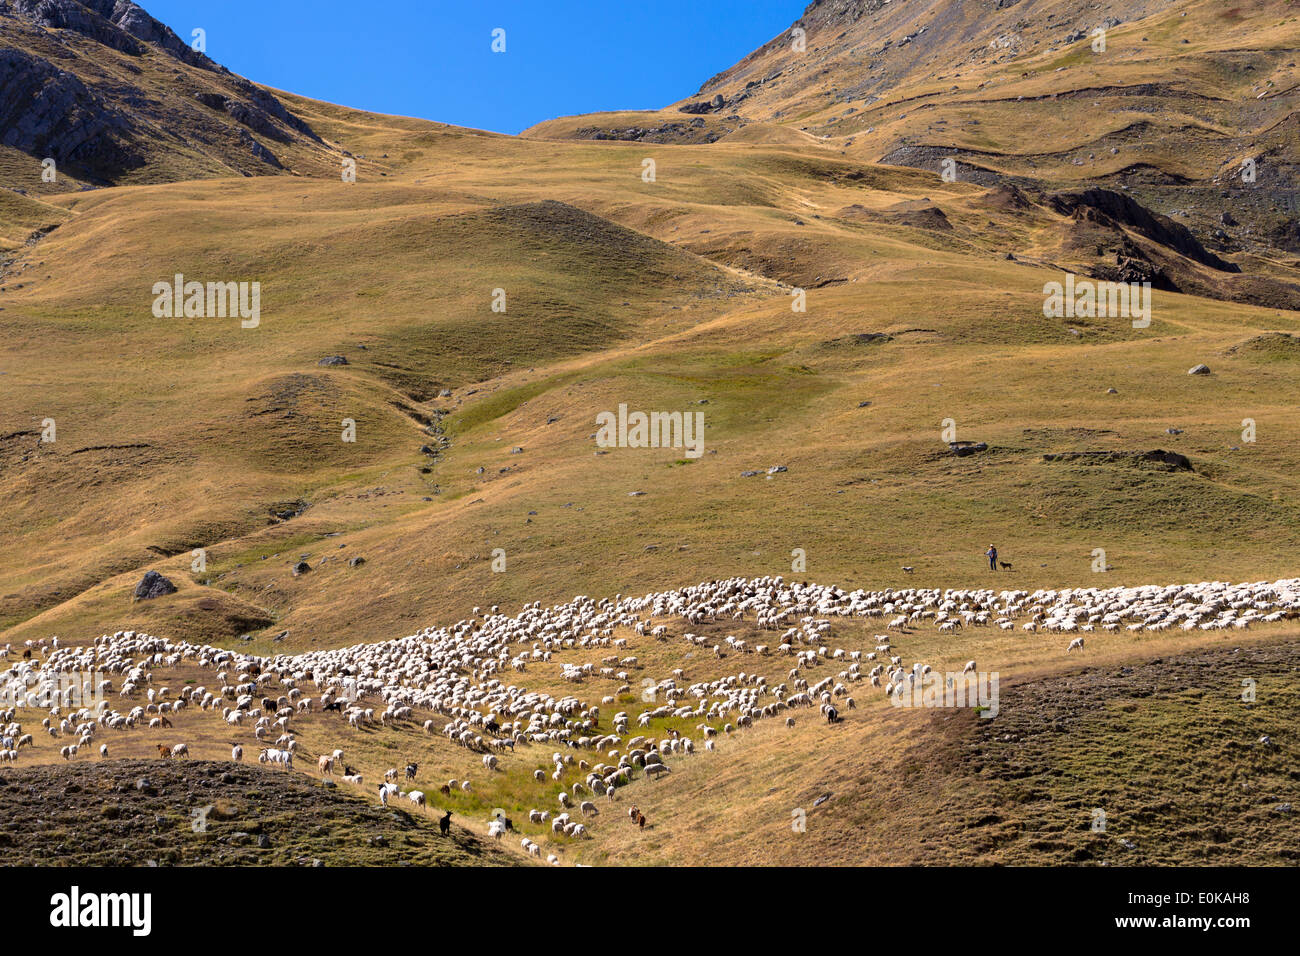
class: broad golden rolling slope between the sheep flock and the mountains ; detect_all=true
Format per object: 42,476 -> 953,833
0,107 -> 1300,646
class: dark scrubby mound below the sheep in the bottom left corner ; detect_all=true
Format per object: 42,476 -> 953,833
0,754 -> 519,866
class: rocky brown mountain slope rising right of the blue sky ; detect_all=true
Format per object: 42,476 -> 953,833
525,0 -> 1300,265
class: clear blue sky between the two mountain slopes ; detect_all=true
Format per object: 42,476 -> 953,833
138,0 -> 790,133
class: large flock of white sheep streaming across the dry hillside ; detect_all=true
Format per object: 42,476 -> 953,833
0,576 -> 1300,864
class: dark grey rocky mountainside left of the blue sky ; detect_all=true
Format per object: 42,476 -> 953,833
0,0 -> 322,185
